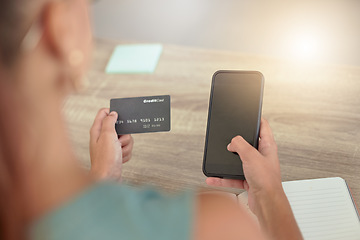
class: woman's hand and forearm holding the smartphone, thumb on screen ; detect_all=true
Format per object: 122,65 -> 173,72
206,119 -> 303,240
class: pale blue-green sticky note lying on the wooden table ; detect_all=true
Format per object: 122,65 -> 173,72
106,44 -> 162,74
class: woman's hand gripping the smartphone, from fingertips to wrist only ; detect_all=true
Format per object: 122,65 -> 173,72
206,119 -> 285,215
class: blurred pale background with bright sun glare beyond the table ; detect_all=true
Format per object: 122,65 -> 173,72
91,0 -> 360,66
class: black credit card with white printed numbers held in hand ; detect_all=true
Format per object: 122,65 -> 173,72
110,95 -> 170,135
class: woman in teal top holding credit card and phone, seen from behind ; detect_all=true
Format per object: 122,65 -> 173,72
0,0 -> 302,240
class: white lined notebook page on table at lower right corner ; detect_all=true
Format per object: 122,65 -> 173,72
283,178 -> 360,240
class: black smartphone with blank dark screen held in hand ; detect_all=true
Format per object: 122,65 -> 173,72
203,70 -> 264,179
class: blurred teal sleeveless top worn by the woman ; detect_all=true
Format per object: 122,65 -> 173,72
30,182 -> 194,240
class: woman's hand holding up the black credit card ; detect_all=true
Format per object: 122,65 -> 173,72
90,108 -> 134,180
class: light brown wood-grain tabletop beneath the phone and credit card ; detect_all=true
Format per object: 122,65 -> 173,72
64,40 -> 360,205
